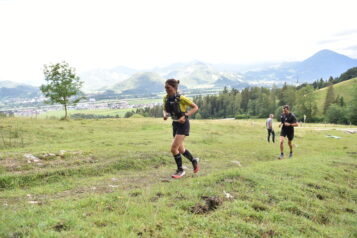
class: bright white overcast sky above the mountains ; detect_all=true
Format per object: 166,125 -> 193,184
0,0 -> 357,85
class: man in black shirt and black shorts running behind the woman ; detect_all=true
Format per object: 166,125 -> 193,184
279,105 -> 298,159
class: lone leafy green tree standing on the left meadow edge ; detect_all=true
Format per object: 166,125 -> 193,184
40,62 -> 84,119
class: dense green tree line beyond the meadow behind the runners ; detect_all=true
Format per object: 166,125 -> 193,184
133,71 -> 357,124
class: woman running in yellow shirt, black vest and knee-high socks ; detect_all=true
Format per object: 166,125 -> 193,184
163,79 -> 199,179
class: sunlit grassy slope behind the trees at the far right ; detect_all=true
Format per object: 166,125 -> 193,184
315,78 -> 357,113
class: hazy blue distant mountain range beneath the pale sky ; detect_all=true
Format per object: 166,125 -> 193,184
0,50 -> 357,98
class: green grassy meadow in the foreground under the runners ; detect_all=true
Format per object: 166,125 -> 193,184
0,118 -> 357,238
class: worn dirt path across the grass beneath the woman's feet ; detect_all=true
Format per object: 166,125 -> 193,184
0,161 -> 238,206
